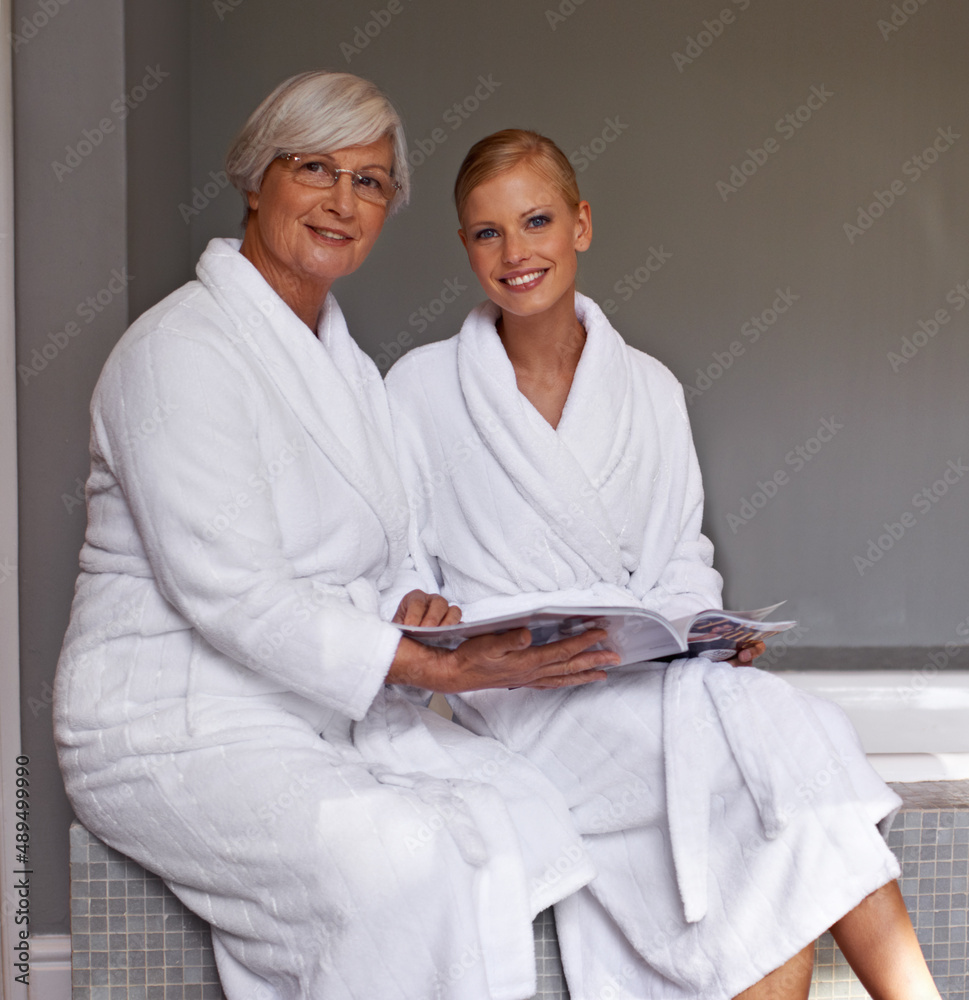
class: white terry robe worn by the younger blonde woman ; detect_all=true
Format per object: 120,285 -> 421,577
387,295 -> 900,1000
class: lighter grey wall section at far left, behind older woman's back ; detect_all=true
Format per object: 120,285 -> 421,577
13,0 -> 127,933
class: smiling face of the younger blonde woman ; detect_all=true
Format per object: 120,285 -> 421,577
458,161 -> 592,318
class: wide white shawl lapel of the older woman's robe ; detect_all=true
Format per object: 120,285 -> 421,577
197,240 -> 408,587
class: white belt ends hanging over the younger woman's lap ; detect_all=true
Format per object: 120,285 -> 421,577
663,658 -> 791,923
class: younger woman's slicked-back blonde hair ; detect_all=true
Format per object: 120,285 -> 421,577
454,128 -> 581,218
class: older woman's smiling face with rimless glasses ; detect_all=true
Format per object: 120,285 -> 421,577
241,137 -> 393,328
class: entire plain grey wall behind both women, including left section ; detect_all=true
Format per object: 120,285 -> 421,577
14,0 -> 969,931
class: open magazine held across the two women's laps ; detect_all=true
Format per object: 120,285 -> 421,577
397,604 -> 797,666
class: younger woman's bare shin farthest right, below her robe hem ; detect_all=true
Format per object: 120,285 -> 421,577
831,882 -> 939,1000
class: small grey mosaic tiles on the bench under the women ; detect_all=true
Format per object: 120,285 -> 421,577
71,782 -> 969,1000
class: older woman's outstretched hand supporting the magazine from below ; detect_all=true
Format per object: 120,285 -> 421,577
386,628 -> 619,694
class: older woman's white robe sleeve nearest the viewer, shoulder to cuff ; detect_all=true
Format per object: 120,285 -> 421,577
92,330 -> 400,719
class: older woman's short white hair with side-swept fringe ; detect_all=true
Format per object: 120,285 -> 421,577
225,70 -> 410,218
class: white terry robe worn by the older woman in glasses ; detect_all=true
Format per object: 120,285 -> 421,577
54,240 -> 594,1000
